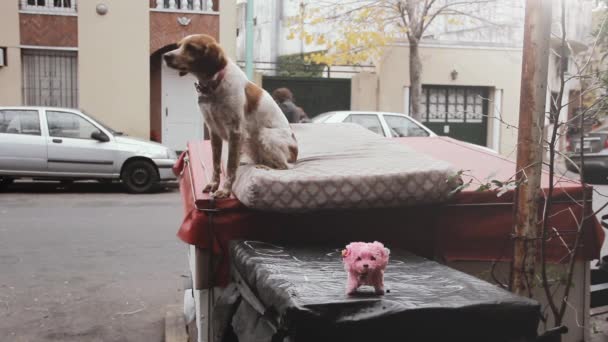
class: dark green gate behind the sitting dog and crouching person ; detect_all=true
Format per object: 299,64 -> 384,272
262,76 -> 350,118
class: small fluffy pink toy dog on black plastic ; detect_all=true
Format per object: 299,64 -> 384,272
342,241 -> 390,295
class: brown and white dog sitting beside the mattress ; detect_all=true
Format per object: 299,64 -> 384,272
164,34 -> 298,198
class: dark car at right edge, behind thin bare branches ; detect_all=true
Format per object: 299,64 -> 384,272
566,126 -> 608,183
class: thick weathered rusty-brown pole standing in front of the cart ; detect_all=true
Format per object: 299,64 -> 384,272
509,0 -> 552,295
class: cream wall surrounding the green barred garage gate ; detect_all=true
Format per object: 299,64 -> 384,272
378,45 -> 522,157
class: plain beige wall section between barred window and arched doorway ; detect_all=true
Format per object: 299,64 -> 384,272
78,0 -> 150,138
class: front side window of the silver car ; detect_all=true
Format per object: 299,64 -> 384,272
46,111 -> 99,139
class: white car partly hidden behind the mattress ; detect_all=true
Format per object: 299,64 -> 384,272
312,111 -> 436,138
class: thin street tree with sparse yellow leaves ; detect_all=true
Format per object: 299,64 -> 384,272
288,0 -> 504,119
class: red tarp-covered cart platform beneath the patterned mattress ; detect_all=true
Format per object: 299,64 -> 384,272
174,124 -> 604,288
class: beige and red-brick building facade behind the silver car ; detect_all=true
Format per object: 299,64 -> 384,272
0,0 -> 236,150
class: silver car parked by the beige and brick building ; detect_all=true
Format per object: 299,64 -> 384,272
0,107 -> 177,193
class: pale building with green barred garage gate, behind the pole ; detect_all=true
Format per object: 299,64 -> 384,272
370,0 -> 596,158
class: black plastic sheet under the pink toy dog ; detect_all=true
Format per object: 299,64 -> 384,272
230,241 -> 540,342
